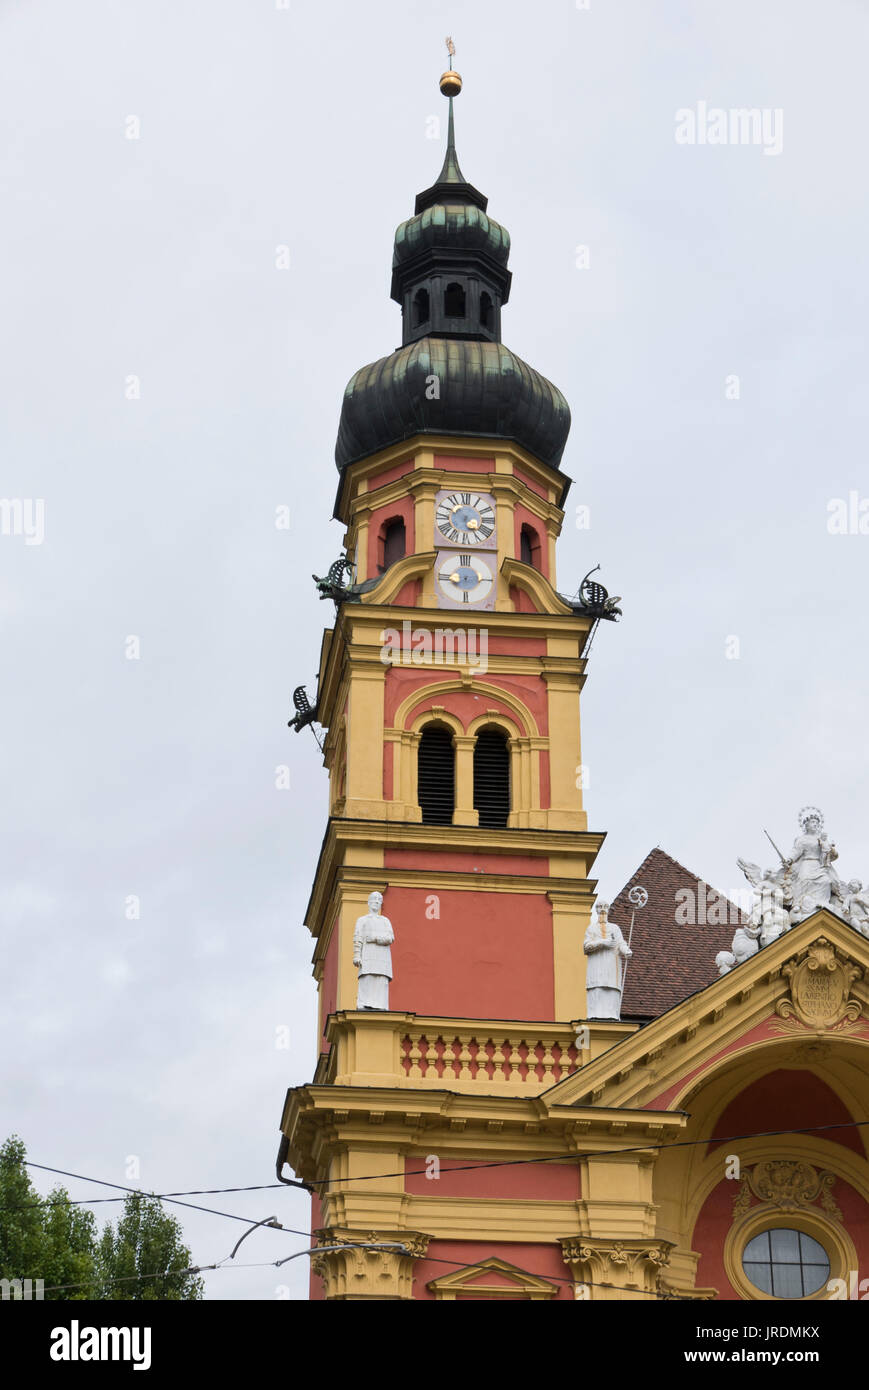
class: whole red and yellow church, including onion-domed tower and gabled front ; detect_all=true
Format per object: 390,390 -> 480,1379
279,71 -> 869,1301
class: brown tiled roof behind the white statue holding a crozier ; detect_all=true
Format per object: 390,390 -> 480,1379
609,849 -> 741,1019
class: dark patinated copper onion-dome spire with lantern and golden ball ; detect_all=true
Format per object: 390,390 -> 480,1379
335,70 -> 570,470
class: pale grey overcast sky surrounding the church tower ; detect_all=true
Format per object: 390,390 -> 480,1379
0,0 -> 869,1298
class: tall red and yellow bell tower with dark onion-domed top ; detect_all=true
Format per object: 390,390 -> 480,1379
281,56 -> 612,1298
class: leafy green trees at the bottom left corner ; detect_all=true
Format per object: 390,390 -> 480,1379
0,1134 -> 203,1301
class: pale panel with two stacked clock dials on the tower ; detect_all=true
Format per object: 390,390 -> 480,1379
435,491 -> 498,609
